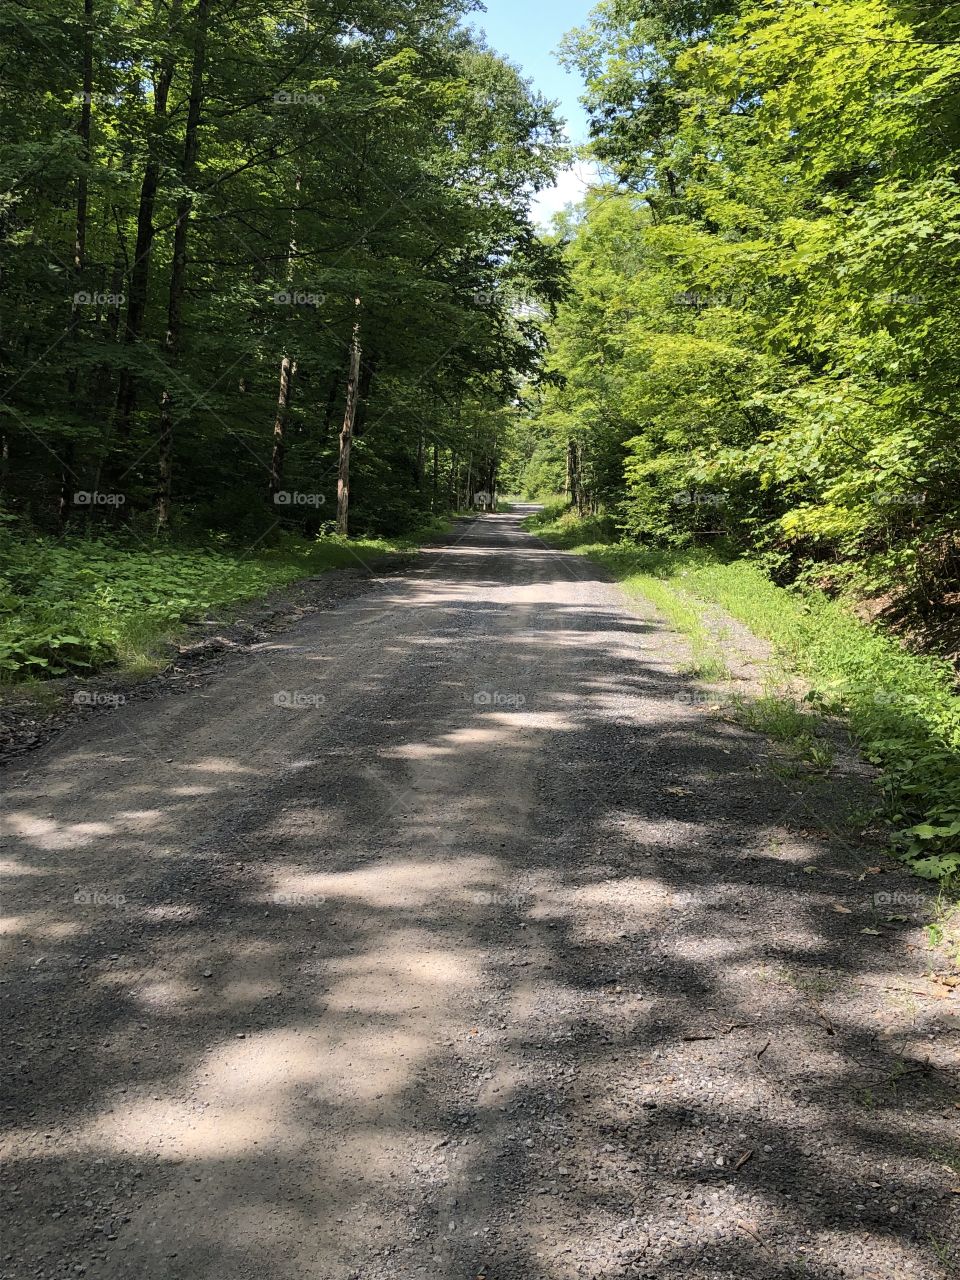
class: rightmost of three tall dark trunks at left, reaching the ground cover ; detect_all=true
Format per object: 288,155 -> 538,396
156,0 -> 210,532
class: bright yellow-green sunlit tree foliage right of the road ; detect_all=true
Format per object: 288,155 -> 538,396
525,0 -> 960,653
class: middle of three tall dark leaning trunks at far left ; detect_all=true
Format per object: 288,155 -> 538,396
116,0 -> 183,435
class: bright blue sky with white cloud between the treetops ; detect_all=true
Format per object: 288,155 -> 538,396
471,0 -> 594,227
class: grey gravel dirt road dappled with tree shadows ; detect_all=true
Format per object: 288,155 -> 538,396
3,516 -> 960,1280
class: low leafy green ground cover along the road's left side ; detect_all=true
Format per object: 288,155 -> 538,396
0,531 -> 427,684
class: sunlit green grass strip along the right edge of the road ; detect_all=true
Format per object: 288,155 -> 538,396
527,503 -> 960,879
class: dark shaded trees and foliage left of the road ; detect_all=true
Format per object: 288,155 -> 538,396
0,0 -> 562,536
